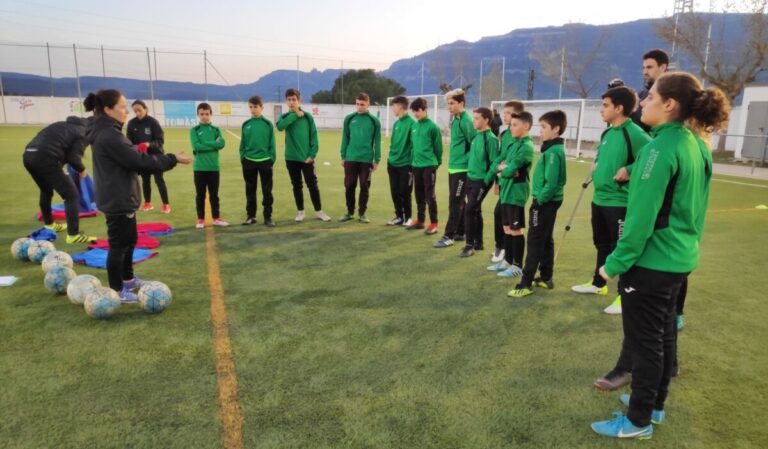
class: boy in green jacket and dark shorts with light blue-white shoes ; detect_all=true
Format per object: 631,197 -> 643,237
493,111 -> 533,278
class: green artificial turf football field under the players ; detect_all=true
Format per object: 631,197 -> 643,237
0,127 -> 768,449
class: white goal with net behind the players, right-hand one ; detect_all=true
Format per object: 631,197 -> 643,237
491,98 -> 605,157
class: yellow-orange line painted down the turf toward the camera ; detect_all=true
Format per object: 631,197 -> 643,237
205,197 -> 245,449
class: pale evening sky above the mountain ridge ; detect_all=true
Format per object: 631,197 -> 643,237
0,0 -> 688,84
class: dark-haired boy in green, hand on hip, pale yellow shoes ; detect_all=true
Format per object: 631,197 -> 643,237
571,86 -> 651,313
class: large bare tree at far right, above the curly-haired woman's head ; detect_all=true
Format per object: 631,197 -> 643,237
656,0 -> 768,151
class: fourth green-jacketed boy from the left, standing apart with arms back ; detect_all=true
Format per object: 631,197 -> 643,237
339,92 -> 381,223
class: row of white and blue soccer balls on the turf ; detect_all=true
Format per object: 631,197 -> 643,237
11,238 -> 173,320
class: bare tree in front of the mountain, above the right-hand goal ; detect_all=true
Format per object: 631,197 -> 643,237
528,24 -> 610,98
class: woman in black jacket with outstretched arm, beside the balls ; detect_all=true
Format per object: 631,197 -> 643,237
83,89 -> 192,302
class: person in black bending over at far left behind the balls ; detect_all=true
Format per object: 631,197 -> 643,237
24,116 -> 96,244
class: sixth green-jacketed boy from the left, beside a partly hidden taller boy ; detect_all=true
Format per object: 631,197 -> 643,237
405,98 -> 443,234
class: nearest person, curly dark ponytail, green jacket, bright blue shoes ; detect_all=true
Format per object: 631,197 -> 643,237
592,72 -> 730,439
